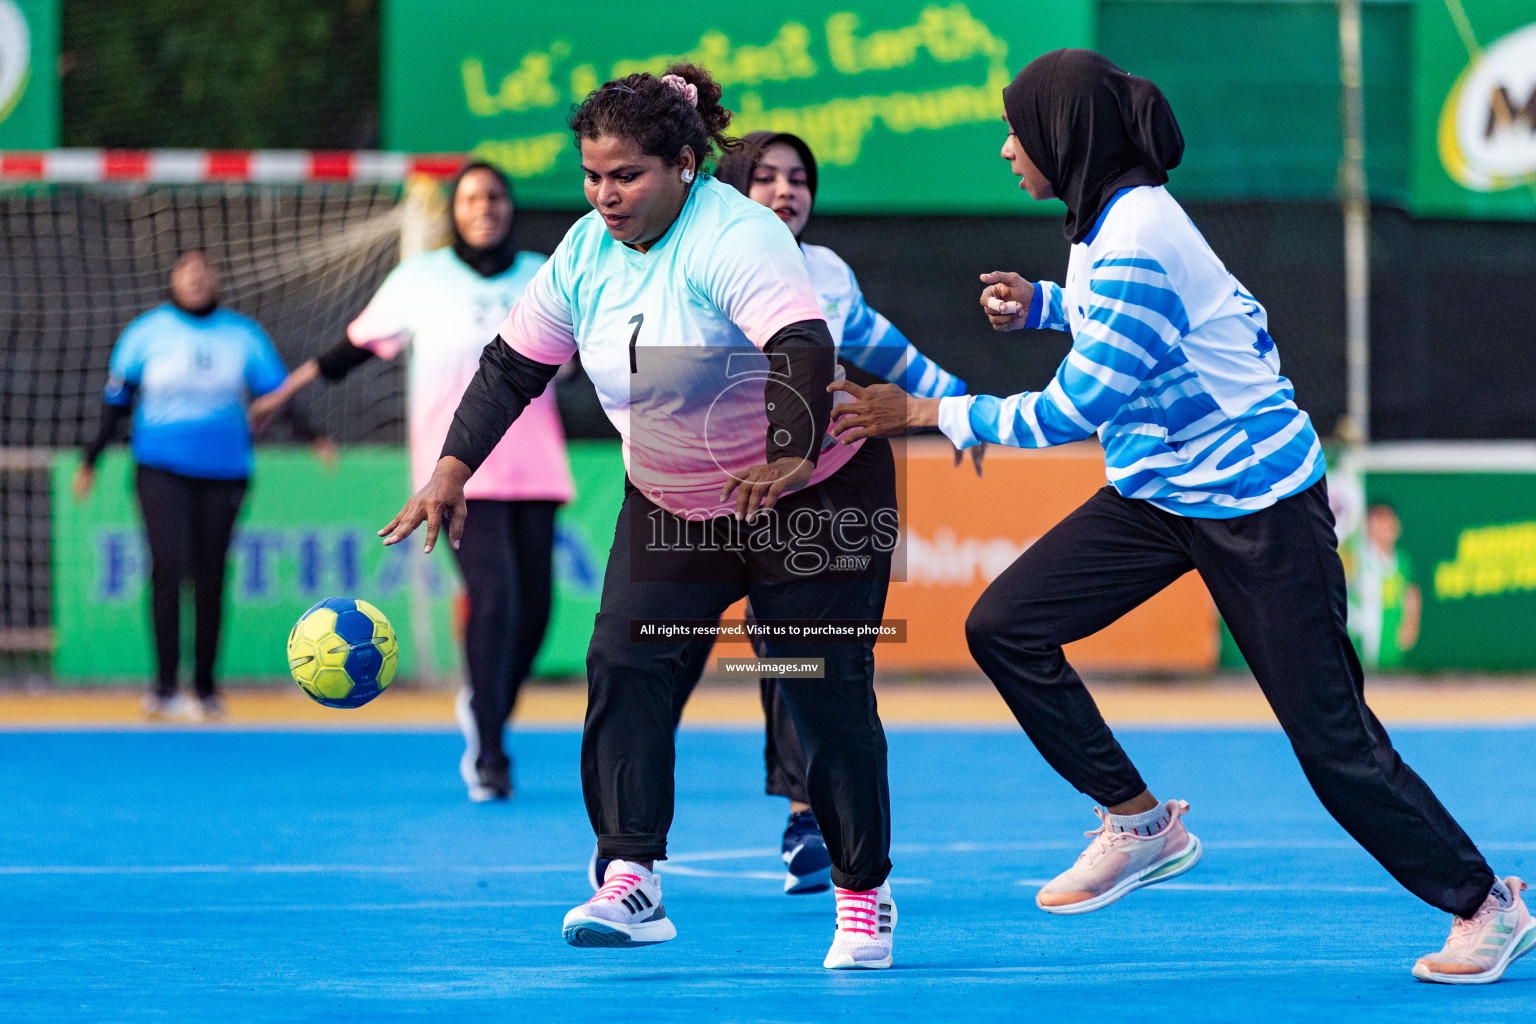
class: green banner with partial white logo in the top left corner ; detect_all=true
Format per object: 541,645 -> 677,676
0,0 -> 58,149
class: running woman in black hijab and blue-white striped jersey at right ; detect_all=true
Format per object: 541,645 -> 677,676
831,49 -> 1536,984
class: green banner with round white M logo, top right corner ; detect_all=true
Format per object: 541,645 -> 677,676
1412,0 -> 1536,220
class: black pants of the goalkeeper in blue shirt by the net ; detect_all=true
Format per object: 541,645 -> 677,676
137,465 -> 247,697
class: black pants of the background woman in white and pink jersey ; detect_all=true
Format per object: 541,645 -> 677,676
455,499 -> 559,768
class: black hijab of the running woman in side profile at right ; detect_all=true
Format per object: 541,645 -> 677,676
1003,49 -> 1184,243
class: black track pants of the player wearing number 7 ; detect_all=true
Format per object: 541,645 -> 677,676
581,441 -> 895,889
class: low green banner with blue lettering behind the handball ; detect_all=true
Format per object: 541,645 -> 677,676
52,442 -> 624,683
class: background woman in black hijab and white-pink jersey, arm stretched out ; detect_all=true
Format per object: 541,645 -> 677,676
252,163 -> 573,801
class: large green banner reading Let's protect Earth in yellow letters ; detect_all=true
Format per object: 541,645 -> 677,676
382,0 -> 1094,215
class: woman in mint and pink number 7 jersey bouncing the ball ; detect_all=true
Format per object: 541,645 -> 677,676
379,64 -> 897,969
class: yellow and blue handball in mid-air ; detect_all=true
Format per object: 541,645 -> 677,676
289,597 -> 399,708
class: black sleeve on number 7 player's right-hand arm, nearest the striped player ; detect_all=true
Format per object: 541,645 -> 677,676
763,319 -> 837,464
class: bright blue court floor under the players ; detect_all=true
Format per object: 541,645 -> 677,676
0,731 -> 1536,1024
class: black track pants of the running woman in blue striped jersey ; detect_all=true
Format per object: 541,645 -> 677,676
966,481 -> 1493,917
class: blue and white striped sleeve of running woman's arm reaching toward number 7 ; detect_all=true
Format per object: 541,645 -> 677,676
938,253 -> 1189,448
